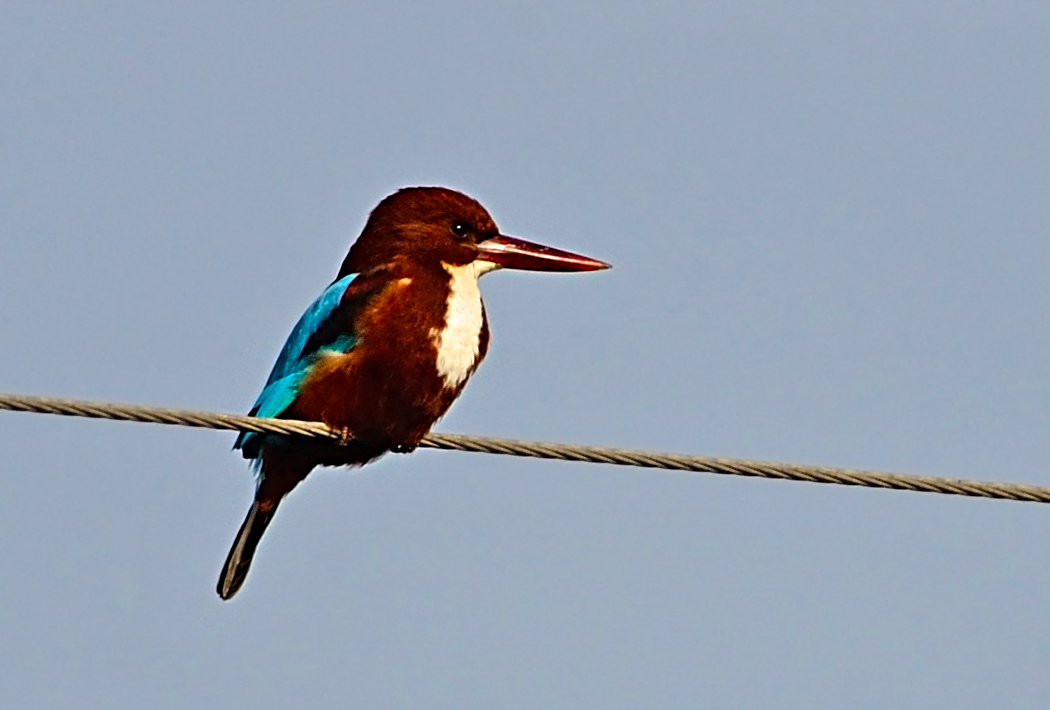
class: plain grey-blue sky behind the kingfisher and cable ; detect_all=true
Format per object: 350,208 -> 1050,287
0,0 -> 1050,710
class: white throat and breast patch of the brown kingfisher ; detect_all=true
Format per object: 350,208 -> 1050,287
431,259 -> 500,390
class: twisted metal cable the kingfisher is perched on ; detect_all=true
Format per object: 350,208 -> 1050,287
0,394 -> 1050,503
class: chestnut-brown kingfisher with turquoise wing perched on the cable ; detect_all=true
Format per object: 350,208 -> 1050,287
216,187 -> 610,600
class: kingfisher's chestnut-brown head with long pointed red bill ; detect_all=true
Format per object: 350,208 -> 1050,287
339,187 -> 609,275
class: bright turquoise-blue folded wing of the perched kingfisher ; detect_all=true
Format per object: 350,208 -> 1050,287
233,274 -> 357,458
